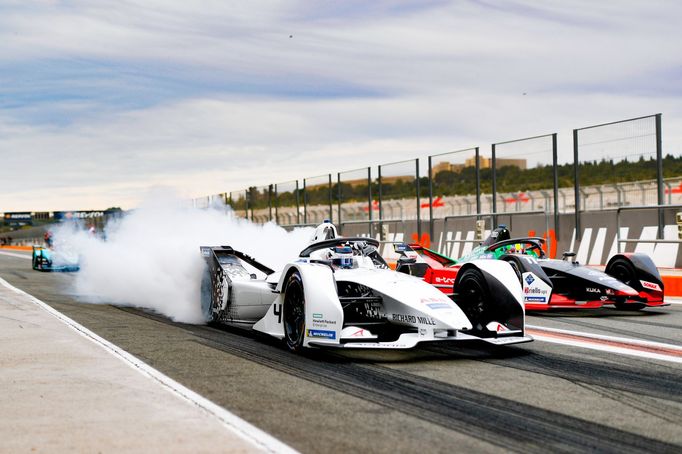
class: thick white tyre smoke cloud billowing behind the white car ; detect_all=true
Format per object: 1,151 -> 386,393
55,196 -> 312,323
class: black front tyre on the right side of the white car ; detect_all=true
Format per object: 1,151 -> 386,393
454,268 -> 490,331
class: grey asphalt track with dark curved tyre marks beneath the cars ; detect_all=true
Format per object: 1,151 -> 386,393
0,251 -> 682,453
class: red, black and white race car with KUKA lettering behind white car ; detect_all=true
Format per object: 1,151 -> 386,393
398,225 -> 667,310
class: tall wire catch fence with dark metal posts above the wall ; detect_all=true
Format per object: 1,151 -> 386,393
201,114 -> 668,237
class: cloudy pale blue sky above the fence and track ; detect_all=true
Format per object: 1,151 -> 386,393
0,0 -> 682,212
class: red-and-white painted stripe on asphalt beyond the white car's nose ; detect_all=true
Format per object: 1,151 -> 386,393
526,325 -> 682,364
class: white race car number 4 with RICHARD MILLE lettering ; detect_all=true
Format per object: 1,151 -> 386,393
201,222 -> 532,351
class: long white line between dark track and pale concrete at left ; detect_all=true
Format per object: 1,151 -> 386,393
0,276 -> 298,454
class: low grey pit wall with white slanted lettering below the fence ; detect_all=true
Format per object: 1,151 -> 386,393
340,208 -> 682,268
